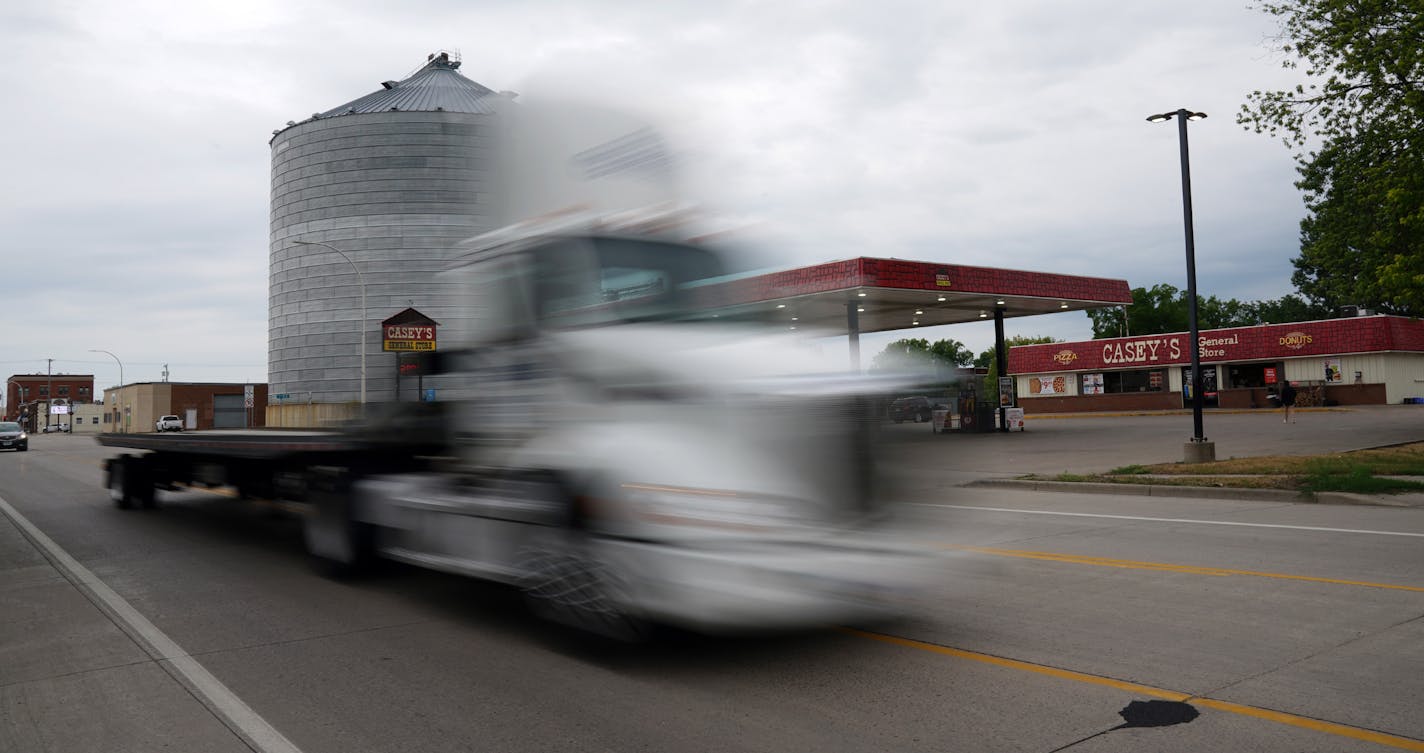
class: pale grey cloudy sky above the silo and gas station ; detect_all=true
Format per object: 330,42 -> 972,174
0,0 -> 1303,401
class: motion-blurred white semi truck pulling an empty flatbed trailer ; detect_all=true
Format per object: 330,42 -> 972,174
98,102 -> 934,639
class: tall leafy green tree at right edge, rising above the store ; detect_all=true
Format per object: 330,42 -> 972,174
1236,0 -> 1424,315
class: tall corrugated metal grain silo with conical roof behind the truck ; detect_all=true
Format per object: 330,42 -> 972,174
268,53 -> 507,415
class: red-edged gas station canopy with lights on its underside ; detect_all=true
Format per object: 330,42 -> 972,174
713,256 -> 1132,331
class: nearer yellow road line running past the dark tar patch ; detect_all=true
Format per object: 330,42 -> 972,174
842,628 -> 1424,753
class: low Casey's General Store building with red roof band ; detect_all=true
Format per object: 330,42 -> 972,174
1008,315 -> 1424,413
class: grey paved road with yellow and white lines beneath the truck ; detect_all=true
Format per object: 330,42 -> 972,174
0,429 -> 1424,753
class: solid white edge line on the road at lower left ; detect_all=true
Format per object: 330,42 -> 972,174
0,497 -> 302,753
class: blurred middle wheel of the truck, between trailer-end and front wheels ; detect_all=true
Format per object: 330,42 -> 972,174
302,468 -> 376,579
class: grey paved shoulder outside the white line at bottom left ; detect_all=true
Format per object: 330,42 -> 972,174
0,492 -> 262,753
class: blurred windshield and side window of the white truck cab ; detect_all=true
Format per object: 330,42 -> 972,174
534,238 -> 722,327
